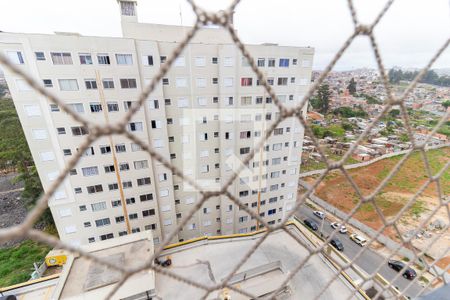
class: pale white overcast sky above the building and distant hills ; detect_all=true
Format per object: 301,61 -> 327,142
0,0 -> 450,70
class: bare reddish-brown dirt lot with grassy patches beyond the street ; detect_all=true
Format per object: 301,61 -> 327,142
307,147 -> 450,265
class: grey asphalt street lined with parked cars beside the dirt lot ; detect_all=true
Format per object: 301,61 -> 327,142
296,206 -> 422,298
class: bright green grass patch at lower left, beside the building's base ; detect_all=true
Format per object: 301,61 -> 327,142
0,240 -> 51,287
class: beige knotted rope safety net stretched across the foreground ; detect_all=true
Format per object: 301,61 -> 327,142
0,0 -> 450,299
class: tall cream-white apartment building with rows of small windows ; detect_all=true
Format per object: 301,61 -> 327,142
0,1 -> 314,245
